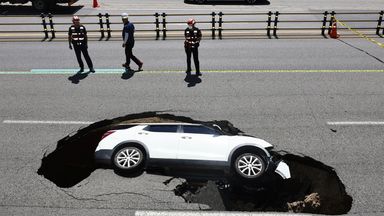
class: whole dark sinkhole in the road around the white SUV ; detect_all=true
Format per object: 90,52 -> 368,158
37,112 -> 352,215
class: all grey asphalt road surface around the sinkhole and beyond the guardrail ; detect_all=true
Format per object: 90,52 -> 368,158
0,0 -> 384,215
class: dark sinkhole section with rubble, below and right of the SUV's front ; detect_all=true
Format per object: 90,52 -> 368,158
175,153 -> 352,215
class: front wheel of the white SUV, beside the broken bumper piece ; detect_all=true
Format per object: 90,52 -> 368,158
233,152 -> 266,180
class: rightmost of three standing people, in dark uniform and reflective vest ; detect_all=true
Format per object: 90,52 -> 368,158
184,19 -> 201,76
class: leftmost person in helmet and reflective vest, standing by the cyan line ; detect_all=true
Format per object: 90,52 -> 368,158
68,16 -> 95,73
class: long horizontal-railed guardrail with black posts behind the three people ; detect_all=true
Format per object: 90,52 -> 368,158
0,11 -> 384,41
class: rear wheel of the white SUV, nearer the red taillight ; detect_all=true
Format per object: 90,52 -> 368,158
112,145 -> 145,174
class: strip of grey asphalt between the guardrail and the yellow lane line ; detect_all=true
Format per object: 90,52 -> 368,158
0,38 -> 384,72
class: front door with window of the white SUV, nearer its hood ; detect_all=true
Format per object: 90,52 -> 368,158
177,125 -> 228,161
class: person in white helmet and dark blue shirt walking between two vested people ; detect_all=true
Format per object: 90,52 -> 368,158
121,13 -> 143,71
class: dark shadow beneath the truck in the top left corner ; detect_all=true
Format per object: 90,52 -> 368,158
0,5 -> 84,15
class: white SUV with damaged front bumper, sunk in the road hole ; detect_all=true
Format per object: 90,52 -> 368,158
95,123 -> 290,179
